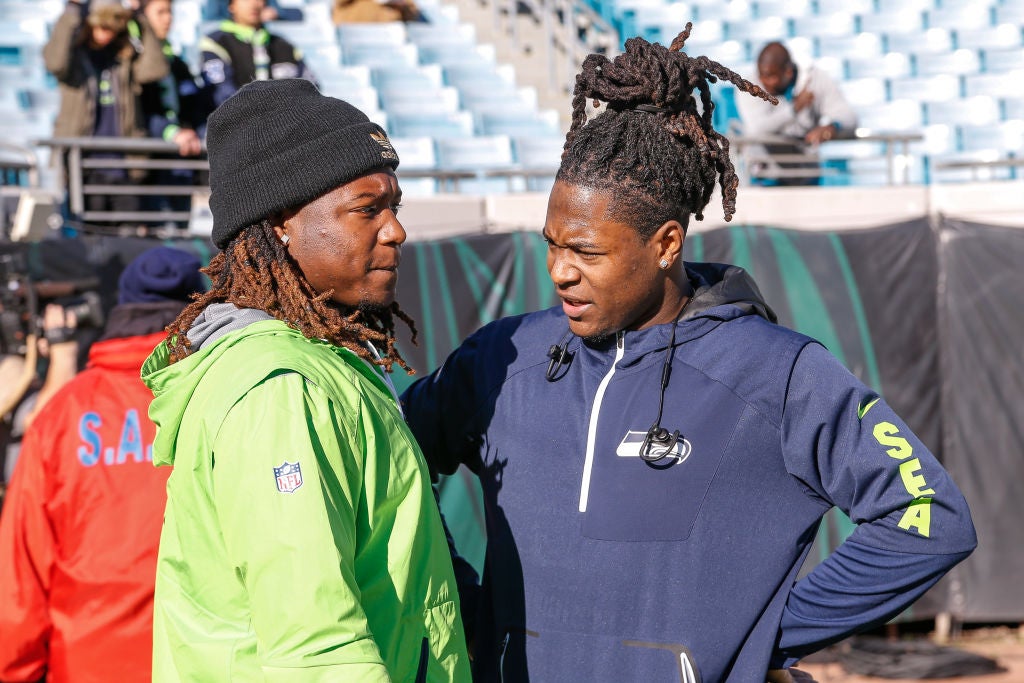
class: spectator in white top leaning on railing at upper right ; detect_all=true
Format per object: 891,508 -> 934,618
736,42 -> 857,184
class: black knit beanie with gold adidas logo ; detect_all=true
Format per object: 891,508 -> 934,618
206,79 -> 398,249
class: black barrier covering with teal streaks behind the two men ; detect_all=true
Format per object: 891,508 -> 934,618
7,218 -> 1024,622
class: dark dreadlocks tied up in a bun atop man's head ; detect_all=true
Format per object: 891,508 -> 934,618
556,23 -> 777,240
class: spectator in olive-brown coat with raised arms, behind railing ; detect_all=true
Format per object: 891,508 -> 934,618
43,0 -> 168,216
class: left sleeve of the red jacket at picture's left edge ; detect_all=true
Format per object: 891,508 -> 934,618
0,418 -> 56,681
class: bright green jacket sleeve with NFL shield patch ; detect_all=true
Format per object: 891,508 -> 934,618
213,374 -> 390,683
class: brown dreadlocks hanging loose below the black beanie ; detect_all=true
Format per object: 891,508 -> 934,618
167,220 -> 417,375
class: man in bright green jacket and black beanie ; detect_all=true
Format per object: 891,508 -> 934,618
142,80 -> 469,683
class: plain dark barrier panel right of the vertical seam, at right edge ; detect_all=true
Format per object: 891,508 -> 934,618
939,220 -> 1024,622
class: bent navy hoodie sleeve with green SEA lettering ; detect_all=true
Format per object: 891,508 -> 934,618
772,344 -> 977,667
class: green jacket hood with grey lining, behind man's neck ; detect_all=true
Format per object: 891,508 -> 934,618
142,304 -> 276,465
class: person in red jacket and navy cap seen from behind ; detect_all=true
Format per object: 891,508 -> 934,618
0,247 -> 206,683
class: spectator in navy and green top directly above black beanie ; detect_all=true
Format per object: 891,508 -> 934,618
200,0 -> 314,108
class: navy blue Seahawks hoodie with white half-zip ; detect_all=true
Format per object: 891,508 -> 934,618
403,264 -> 976,683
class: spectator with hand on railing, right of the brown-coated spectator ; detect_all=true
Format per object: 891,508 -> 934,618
141,0 -> 208,157
